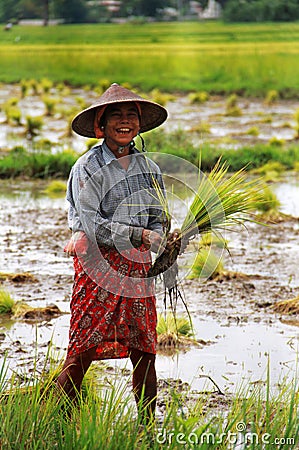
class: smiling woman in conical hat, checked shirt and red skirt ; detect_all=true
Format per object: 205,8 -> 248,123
57,84 -> 171,418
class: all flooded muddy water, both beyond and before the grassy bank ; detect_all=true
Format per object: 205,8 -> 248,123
0,86 -> 299,404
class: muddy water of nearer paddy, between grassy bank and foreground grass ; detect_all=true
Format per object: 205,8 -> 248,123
0,176 -> 299,391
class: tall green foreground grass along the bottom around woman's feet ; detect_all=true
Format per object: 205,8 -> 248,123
0,356 -> 299,450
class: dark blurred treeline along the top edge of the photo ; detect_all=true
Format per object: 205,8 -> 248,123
0,0 -> 299,25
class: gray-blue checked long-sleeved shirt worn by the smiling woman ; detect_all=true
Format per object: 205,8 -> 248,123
67,142 -> 166,249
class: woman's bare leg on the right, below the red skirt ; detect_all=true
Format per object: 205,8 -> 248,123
130,349 -> 157,422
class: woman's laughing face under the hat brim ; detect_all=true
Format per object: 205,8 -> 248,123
104,102 -> 140,150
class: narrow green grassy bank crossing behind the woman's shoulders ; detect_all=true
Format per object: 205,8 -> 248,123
0,135 -> 299,179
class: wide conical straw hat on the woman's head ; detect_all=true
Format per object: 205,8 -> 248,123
72,83 -> 167,138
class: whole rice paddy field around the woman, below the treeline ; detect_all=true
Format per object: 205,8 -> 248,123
0,22 -> 299,450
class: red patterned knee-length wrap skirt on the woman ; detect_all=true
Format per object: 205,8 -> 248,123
67,246 -> 157,359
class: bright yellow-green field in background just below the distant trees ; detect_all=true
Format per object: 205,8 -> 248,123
0,22 -> 299,97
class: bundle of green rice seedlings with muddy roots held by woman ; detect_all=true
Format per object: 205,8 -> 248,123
148,160 -> 262,289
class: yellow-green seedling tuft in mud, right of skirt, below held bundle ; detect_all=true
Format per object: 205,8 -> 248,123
188,247 -> 224,280
